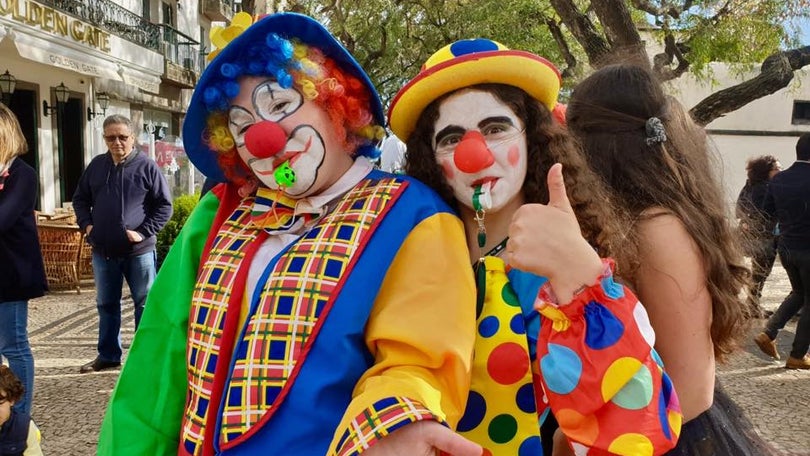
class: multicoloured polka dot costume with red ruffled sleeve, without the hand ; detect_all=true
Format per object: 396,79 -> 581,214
458,257 -> 681,456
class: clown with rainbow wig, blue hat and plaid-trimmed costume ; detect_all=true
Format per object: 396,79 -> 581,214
98,14 -> 481,456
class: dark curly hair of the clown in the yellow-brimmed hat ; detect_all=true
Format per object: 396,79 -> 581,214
405,84 -> 621,256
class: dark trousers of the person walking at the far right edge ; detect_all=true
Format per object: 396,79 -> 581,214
765,247 -> 810,359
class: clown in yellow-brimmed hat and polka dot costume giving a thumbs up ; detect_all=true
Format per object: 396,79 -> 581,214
389,39 -> 680,455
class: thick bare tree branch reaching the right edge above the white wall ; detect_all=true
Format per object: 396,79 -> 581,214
689,46 -> 810,125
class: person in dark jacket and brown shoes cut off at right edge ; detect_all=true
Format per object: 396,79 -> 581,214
755,133 -> 810,369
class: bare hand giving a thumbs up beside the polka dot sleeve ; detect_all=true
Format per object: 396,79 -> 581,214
506,163 -> 602,304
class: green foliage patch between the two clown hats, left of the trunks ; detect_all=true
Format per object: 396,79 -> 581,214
278,0 -> 563,105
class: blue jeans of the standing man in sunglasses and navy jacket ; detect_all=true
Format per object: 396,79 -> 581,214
93,250 -> 156,363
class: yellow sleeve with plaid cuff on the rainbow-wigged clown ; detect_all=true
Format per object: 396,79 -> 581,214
329,214 -> 475,455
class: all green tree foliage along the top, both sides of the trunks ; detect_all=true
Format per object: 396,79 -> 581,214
262,0 -> 810,117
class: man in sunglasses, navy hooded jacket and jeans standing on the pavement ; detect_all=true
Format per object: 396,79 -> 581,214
73,114 -> 172,373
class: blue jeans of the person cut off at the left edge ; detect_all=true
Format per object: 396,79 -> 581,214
0,301 -> 34,414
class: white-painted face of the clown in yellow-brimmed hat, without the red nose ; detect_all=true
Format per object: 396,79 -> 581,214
433,90 -> 527,216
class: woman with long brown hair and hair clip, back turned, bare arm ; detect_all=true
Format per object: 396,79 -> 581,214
566,65 -> 768,455
